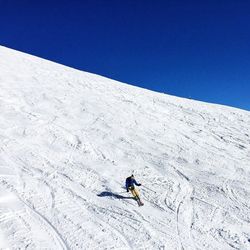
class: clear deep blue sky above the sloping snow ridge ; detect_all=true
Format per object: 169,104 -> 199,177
0,0 -> 250,110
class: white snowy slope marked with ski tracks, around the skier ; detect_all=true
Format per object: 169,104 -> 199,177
0,47 -> 250,250
